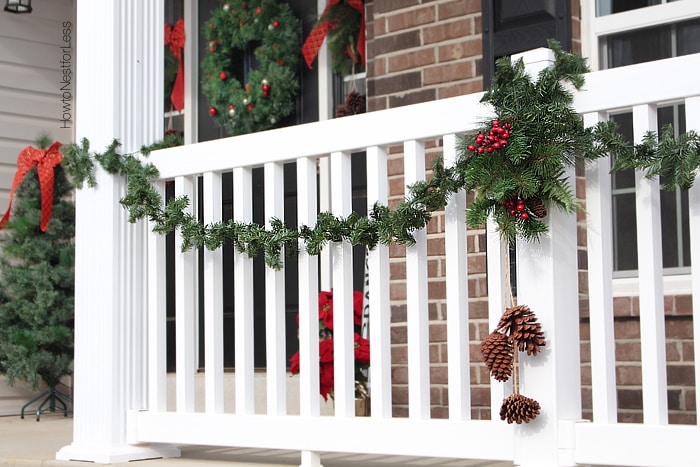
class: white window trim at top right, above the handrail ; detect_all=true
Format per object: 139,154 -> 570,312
581,0 -> 700,71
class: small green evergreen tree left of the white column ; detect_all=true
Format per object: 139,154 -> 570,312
0,137 -> 75,390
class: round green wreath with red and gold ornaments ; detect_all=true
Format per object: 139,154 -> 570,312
202,0 -> 301,135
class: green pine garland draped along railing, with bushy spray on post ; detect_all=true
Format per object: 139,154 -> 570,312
62,44 -> 700,269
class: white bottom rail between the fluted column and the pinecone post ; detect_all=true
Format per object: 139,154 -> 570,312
129,411 -> 514,461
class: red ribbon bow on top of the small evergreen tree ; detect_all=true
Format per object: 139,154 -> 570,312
0,141 -> 63,232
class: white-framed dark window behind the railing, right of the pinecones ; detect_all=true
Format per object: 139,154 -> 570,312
582,0 -> 700,278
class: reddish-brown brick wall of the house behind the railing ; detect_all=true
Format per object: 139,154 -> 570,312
365,0 -> 695,423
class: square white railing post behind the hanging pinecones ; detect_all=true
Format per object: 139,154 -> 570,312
515,49 -> 581,467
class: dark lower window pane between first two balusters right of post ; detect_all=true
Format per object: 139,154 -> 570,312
613,193 -> 637,271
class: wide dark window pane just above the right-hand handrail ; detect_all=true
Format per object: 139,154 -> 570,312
607,26 -> 671,68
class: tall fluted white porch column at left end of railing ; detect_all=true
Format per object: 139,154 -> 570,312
56,0 -> 179,463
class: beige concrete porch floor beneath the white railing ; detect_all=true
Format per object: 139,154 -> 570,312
0,413 -> 513,467
